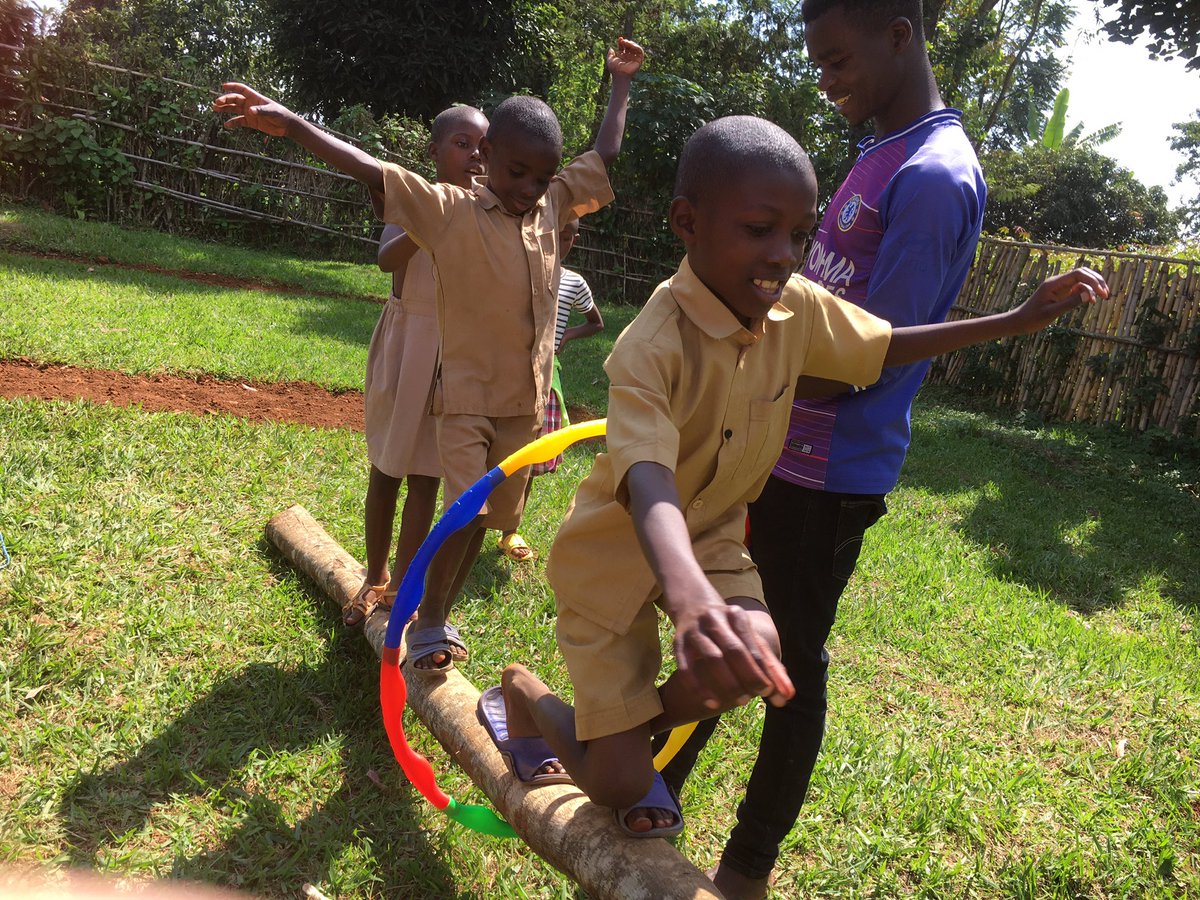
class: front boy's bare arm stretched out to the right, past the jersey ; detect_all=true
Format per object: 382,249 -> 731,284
883,269 -> 1109,366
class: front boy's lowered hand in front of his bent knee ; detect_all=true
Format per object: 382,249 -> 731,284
674,600 -> 796,709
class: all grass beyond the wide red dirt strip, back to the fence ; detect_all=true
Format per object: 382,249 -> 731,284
0,200 -> 636,413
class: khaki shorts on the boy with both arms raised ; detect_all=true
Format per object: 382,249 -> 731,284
438,413 -> 542,532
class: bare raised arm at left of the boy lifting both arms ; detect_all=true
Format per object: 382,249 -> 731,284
212,82 -> 383,193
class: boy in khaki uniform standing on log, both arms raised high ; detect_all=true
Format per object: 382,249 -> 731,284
214,38 -> 644,672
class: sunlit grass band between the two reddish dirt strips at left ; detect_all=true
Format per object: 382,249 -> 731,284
0,253 -> 382,390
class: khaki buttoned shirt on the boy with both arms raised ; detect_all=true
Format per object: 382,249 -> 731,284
380,151 -> 613,416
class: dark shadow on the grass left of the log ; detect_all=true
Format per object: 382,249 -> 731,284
60,566 -> 472,898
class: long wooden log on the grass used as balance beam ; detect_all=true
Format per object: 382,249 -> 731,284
266,504 -> 721,900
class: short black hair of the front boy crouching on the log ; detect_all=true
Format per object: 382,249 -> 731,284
674,115 -> 816,203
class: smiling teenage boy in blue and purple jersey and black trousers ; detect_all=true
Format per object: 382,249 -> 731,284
664,0 -> 986,900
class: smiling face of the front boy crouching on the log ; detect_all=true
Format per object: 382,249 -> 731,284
671,168 -> 817,325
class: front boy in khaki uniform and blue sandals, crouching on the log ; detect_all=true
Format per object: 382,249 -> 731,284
480,116 -> 1108,836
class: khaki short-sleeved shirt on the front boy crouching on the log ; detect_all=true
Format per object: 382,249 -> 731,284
547,259 -> 892,634
